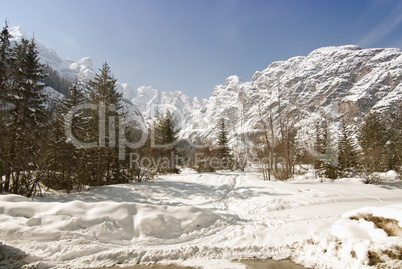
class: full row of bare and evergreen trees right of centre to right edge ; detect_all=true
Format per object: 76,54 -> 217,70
253,100 -> 402,180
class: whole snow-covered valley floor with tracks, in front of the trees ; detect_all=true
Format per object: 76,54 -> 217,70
0,171 -> 402,268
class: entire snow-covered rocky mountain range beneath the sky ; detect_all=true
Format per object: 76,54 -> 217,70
11,27 -> 402,145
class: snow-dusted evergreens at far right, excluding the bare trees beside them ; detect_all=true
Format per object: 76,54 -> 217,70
314,108 -> 402,183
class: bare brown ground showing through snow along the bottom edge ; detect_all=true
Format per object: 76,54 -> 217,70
99,260 -> 306,269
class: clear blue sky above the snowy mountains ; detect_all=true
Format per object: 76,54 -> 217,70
0,0 -> 402,98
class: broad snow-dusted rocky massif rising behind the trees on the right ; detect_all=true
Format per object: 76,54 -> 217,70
252,46 -> 402,117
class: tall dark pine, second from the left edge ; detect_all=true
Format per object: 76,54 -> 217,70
5,39 -> 48,193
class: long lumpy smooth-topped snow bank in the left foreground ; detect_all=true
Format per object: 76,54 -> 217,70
0,195 -> 220,241
